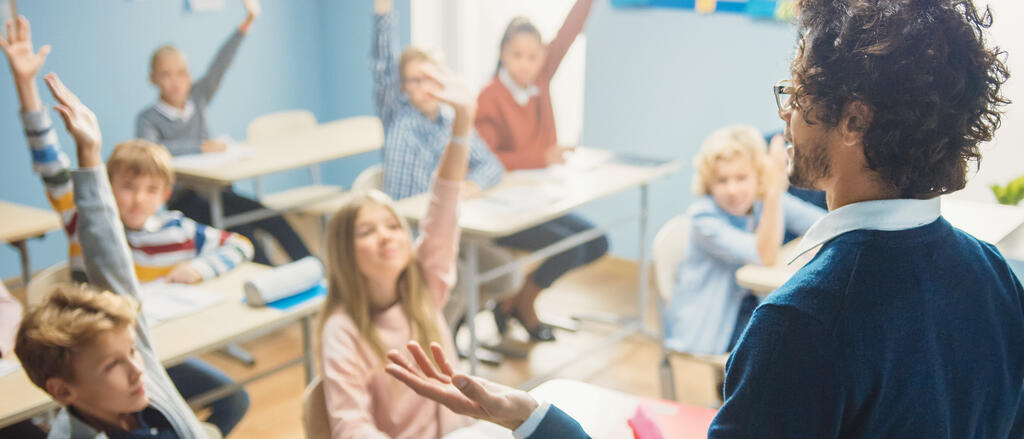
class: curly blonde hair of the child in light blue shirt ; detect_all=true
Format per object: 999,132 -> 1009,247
693,125 -> 768,195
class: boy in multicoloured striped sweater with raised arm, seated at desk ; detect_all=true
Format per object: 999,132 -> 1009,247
2,17 -> 253,434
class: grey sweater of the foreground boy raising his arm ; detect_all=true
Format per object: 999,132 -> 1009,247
49,167 -> 206,439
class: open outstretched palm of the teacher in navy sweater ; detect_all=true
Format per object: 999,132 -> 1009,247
385,342 -> 538,430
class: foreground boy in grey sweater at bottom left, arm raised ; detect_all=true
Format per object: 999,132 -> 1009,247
14,71 -> 206,439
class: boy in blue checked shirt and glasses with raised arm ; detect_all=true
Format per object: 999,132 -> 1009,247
373,0 -> 522,335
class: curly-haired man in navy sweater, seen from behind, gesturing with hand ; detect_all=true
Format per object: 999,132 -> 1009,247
387,0 -> 1024,433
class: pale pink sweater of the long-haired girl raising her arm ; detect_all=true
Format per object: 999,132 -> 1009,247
322,180 -> 470,439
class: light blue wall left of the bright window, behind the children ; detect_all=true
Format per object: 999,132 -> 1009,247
0,0 -> 410,277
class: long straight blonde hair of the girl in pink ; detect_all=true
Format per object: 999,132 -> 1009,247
317,190 -> 441,360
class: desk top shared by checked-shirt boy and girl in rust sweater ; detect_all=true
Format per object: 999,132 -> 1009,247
396,149 -> 679,238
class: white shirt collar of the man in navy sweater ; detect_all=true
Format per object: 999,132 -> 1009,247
788,196 -> 941,264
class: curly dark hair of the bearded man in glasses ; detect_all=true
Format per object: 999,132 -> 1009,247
793,0 -> 1010,199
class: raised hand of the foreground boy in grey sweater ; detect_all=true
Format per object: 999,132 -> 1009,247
43,73 -> 103,168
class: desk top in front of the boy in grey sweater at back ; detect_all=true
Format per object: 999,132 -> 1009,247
174,117 -> 384,186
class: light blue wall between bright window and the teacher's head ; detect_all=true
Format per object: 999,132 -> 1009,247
583,1 -> 796,258
